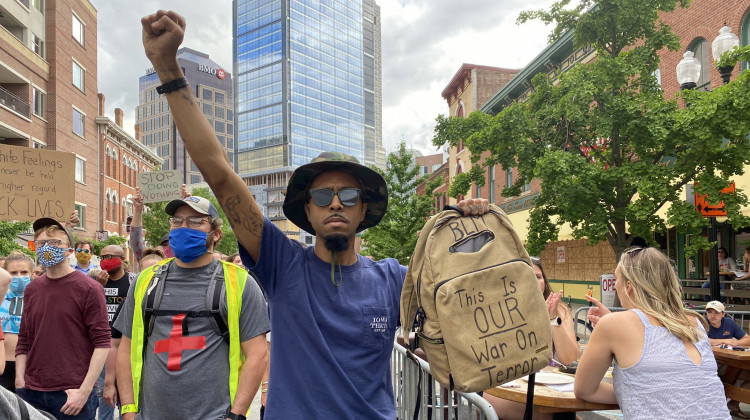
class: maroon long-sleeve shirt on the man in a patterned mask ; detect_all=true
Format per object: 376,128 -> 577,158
16,270 -> 110,391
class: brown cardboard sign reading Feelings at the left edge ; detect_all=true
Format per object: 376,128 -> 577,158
0,144 -> 75,222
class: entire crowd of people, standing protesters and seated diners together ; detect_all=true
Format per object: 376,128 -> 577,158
0,11 -> 750,420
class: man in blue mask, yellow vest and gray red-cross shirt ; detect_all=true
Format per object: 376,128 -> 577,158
114,197 -> 270,420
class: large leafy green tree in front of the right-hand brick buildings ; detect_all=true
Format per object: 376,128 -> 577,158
434,0 -> 750,258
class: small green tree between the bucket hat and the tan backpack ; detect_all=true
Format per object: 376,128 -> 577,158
362,142 -> 442,265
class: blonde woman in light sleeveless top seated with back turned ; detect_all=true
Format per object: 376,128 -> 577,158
575,248 -> 731,420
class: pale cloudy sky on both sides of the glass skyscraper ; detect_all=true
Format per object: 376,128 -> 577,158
92,0 -> 552,154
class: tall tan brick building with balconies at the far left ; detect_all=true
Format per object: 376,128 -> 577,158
0,0 -> 99,238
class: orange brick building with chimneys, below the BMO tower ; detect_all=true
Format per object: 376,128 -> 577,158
96,93 -> 163,240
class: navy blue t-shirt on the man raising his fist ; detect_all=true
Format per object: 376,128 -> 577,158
239,219 -> 406,420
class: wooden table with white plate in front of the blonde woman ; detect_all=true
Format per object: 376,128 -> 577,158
484,366 -> 620,419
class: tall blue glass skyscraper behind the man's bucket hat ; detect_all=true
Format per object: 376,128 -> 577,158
234,0 -> 385,234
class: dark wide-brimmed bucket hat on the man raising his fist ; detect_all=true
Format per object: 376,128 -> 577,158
283,152 -> 388,235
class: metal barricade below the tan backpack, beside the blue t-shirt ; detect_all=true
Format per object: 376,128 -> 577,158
391,342 -> 497,420
